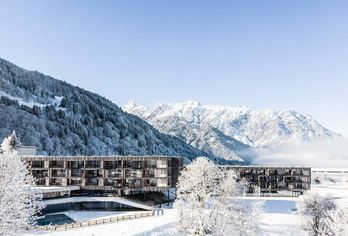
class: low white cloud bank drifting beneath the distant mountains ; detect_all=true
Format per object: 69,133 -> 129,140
253,139 -> 348,168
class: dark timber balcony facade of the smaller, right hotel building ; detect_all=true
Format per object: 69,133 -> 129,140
223,166 -> 311,196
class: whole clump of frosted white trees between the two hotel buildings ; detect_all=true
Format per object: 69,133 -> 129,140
174,157 -> 262,236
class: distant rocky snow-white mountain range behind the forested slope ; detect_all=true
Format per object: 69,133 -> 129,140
123,101 -> 340,161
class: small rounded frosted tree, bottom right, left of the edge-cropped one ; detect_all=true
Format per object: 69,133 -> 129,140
297,190 -> 337,236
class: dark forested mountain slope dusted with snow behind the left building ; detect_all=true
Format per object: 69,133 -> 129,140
0,59 -> 206,159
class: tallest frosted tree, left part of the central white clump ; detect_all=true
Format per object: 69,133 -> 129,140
174,157 -> 221,235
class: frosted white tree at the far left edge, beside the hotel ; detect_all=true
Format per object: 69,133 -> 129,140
0,133 -> 43,235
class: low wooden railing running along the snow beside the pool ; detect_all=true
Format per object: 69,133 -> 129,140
36,210 -> 155,231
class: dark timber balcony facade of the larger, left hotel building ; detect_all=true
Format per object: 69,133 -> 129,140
21,156 -> 182,194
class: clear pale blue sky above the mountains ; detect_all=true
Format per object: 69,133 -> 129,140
0,0 -> 348,136
